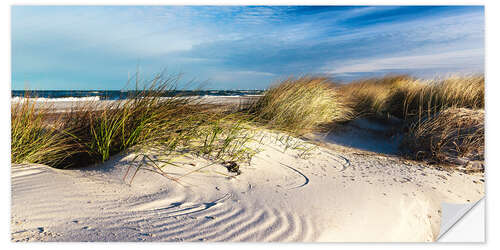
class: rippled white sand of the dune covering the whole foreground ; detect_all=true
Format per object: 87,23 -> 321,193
11,129 -> 484,242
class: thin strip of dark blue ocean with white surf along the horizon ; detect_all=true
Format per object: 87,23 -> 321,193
12,90 -> 264,101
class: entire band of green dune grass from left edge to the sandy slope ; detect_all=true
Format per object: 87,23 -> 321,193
11,74 -> 262,168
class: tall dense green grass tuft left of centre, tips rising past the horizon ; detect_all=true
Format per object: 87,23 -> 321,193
59,75 -> 195,165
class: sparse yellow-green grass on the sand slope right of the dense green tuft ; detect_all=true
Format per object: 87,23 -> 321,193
124,112 -> 259,185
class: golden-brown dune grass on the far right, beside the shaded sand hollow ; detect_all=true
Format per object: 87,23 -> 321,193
339,75 -> 485,162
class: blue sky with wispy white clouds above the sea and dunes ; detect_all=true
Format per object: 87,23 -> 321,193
11,6 -> 485,90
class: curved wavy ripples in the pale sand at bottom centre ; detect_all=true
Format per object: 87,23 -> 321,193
66,191 -> 313,242
